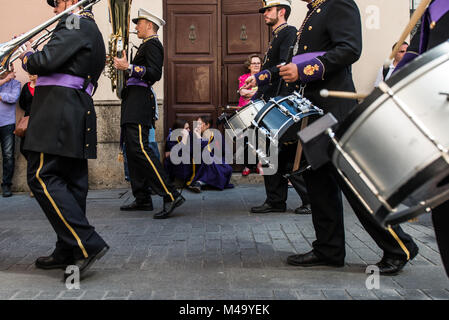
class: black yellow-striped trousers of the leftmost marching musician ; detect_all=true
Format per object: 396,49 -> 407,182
27,151 -> 106,259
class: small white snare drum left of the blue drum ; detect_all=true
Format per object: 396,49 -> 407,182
224,99 -> 265,139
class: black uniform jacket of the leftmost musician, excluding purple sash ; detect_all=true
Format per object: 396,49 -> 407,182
24,16 -> 106,159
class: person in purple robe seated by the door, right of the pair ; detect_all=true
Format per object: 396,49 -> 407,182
187,116 -> 234,193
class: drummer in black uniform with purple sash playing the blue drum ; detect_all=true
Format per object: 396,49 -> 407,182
280,0 -> 418,274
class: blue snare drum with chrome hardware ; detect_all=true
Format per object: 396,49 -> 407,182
248,92 -> 323,164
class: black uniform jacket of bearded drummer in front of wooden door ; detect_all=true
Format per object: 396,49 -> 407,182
253,24 -> 297,101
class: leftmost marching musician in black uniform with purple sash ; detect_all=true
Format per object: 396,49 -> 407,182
21,0 -> 109,278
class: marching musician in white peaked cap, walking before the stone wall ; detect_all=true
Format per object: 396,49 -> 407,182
114,9 -> 185,219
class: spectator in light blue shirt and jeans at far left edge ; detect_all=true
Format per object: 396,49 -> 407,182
0,65 -> 21,197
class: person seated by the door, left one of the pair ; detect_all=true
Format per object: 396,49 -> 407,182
164,119 -> 193,185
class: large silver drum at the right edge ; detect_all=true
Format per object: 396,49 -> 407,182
328,42 -> 449,226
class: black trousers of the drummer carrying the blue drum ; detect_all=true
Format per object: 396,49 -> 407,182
304,163 -> 417,263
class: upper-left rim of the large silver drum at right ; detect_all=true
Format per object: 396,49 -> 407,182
335,41 -> 449,139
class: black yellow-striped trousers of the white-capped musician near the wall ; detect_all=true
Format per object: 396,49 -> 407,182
122,123 -> 179,203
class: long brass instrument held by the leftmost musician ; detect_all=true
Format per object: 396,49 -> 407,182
0,0 -> 101,75
